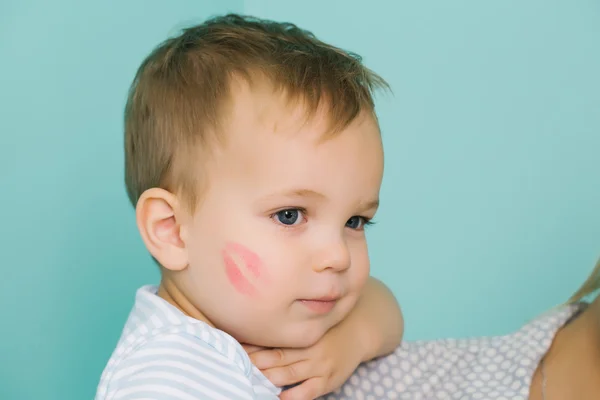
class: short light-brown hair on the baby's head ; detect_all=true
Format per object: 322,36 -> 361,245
125,14 -> 389,209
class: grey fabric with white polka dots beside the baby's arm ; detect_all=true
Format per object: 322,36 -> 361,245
321,306 -> 580,400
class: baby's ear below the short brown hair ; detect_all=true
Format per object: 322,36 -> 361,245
136,188 -> 188,271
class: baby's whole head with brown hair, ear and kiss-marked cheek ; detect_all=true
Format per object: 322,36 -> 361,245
125,15 -> 386,347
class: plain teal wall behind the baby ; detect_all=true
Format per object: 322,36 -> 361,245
0,0 -> 600,400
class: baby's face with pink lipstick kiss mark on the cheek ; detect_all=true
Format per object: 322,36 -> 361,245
183,83 -> 383,347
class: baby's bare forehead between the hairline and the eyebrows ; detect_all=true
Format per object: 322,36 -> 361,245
209,102 -> 383,202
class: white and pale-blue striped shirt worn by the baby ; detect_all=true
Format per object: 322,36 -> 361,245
95,286 -> 281,400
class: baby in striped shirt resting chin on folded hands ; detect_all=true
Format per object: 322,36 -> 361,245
96,15 -> 402,400
